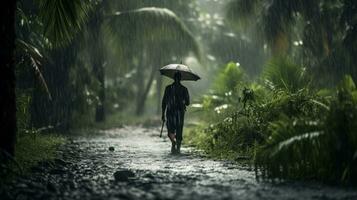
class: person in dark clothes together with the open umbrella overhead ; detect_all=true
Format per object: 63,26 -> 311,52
160,64 -> 200,153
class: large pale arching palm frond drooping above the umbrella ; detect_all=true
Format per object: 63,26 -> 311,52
107,7 -> 201,59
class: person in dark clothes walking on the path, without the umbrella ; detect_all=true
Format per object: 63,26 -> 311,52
161,72 -> 190,154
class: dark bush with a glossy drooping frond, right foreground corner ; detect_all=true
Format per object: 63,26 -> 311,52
255,76 -> 357,183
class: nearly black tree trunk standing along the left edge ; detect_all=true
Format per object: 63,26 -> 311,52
0,0 -> 16,156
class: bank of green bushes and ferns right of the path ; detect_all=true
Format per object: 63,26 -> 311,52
190,59 -> 357,183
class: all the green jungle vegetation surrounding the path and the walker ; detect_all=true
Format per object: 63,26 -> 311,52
0,0 -> 357,184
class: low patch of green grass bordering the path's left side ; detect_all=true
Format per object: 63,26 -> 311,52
0,134 -> 66,184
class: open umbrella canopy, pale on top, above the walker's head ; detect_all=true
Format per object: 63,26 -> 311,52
160,64 -> 201,81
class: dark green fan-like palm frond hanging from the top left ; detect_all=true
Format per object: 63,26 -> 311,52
38,0 -> 91,46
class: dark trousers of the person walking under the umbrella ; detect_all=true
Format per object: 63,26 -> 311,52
166,110 -> 185,142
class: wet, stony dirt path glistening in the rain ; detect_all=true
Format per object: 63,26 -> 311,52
1,127 -> 357,200
